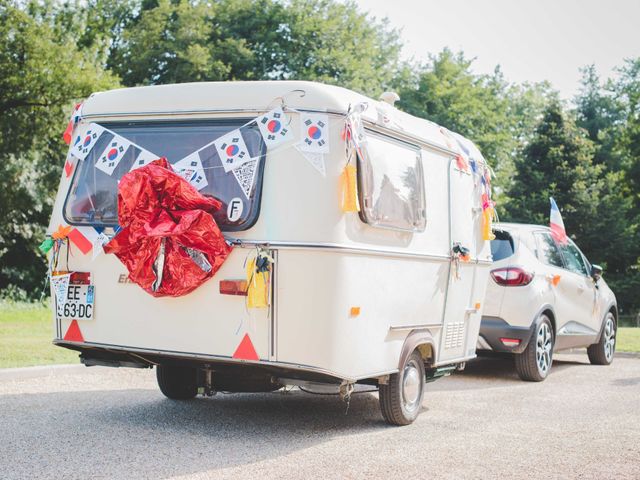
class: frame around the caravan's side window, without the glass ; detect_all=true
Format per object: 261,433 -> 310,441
357,128 -> 427,233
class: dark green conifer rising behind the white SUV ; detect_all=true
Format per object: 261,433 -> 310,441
505,103 -> 635,307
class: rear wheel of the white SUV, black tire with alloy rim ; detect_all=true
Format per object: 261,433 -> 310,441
515,314 -> 555,382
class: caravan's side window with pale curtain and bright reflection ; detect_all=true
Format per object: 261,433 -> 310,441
358,131 -> 427,232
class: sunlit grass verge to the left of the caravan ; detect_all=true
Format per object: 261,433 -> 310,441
0,303 -> 79,368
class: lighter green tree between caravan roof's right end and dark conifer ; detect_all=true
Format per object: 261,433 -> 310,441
399,49 -> 554,200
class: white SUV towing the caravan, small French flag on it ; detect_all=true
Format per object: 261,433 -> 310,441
477,223 -> 618,382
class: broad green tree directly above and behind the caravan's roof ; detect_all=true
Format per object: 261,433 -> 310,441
107,0 -> 401,95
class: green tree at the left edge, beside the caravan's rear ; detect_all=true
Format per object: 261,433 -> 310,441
0,2 -> 116,295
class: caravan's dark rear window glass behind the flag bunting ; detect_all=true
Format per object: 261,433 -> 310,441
64,120 -> 266,231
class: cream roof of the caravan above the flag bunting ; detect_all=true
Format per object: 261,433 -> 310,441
83,80 -> 480,155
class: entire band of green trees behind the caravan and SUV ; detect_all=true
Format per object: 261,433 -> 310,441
0,0 -> 640,316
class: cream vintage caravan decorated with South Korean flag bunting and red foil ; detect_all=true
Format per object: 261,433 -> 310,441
48,81 -> 492,424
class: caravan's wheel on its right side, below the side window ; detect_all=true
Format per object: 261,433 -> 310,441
378,350 -> 425,425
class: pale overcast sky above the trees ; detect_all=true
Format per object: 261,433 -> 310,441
356,0 -> 640,98
